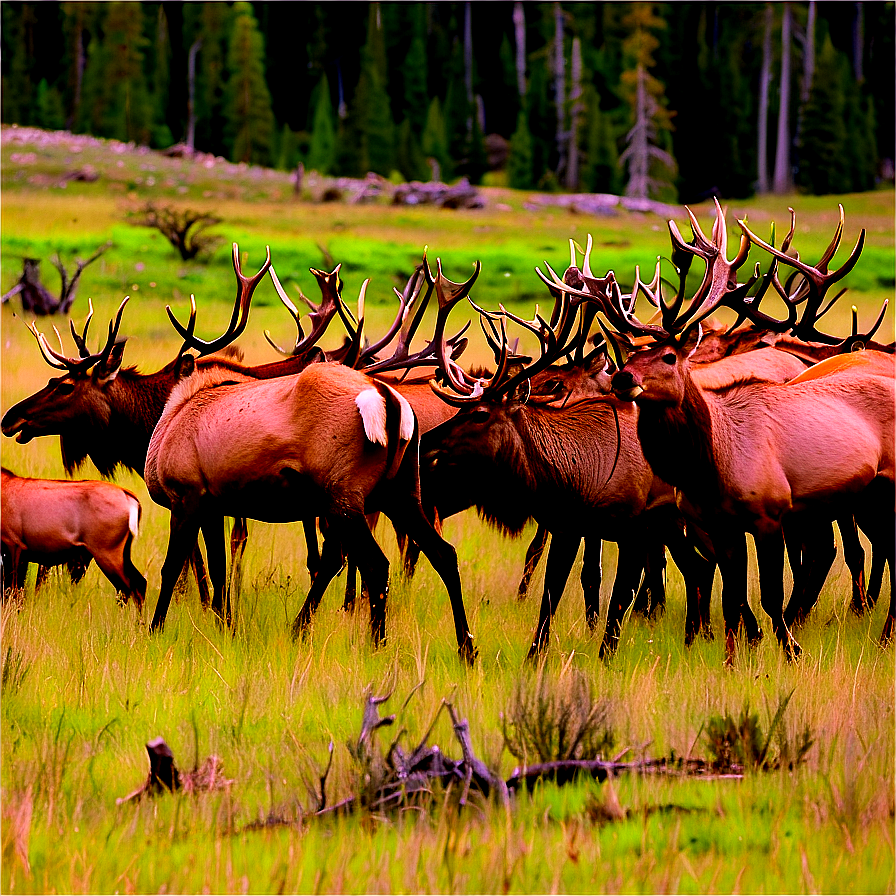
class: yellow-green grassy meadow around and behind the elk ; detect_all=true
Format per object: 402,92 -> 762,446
0,130 -> 896,893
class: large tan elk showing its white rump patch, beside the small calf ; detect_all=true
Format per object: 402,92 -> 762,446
145,256 -> 479,662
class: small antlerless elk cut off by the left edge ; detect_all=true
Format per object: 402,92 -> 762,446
0,467 -> 146,611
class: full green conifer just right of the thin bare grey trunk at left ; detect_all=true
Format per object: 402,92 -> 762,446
224,2 -> 274,164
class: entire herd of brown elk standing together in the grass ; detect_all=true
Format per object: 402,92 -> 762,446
2,202 -> 896,662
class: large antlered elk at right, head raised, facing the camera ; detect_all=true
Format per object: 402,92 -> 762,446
568,203 -> 896,661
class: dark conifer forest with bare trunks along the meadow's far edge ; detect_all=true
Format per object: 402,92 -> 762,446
0,0 -> 896,202
